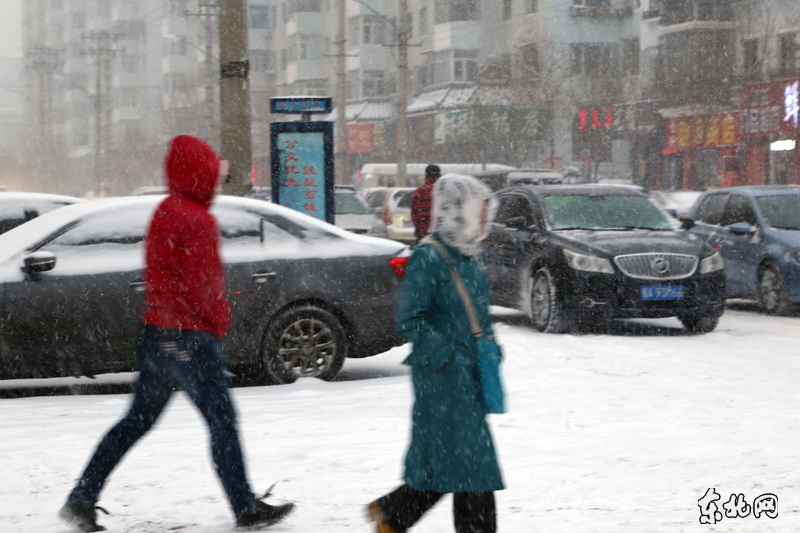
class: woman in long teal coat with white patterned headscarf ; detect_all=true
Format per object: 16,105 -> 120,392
369,174 -> 503,533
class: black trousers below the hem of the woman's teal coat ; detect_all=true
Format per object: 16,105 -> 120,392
378,485 -> 497,533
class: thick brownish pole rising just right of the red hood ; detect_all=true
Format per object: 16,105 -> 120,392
219,0 -> 253,196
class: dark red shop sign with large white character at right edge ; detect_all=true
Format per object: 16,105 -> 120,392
742,80 -> 800,137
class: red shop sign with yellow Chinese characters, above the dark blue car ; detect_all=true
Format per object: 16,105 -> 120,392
664,112 -> 741,154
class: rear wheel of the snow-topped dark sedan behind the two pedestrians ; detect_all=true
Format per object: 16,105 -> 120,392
263,306 -> 347,385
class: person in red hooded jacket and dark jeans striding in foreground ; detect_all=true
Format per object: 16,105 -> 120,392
59,135 -> 294,531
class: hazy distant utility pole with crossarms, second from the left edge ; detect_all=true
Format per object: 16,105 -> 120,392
81,30 -> 122,192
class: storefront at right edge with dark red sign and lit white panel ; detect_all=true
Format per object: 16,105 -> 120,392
741,79 -> 800,185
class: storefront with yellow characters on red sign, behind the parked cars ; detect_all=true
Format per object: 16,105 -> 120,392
659,111 -> 743,190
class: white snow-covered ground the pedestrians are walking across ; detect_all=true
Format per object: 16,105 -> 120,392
0,304 -> 800,533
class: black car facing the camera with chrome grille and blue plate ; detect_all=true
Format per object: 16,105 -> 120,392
485,186 -> 725,332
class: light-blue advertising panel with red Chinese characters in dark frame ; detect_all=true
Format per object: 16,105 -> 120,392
270,122 -> 335,224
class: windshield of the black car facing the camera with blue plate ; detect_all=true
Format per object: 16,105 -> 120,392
544,193 -> 673,230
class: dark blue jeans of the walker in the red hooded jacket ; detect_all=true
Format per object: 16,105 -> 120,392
68,324 -> 255,517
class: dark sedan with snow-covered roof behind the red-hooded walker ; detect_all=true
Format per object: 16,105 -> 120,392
0,196 -> 408,383
